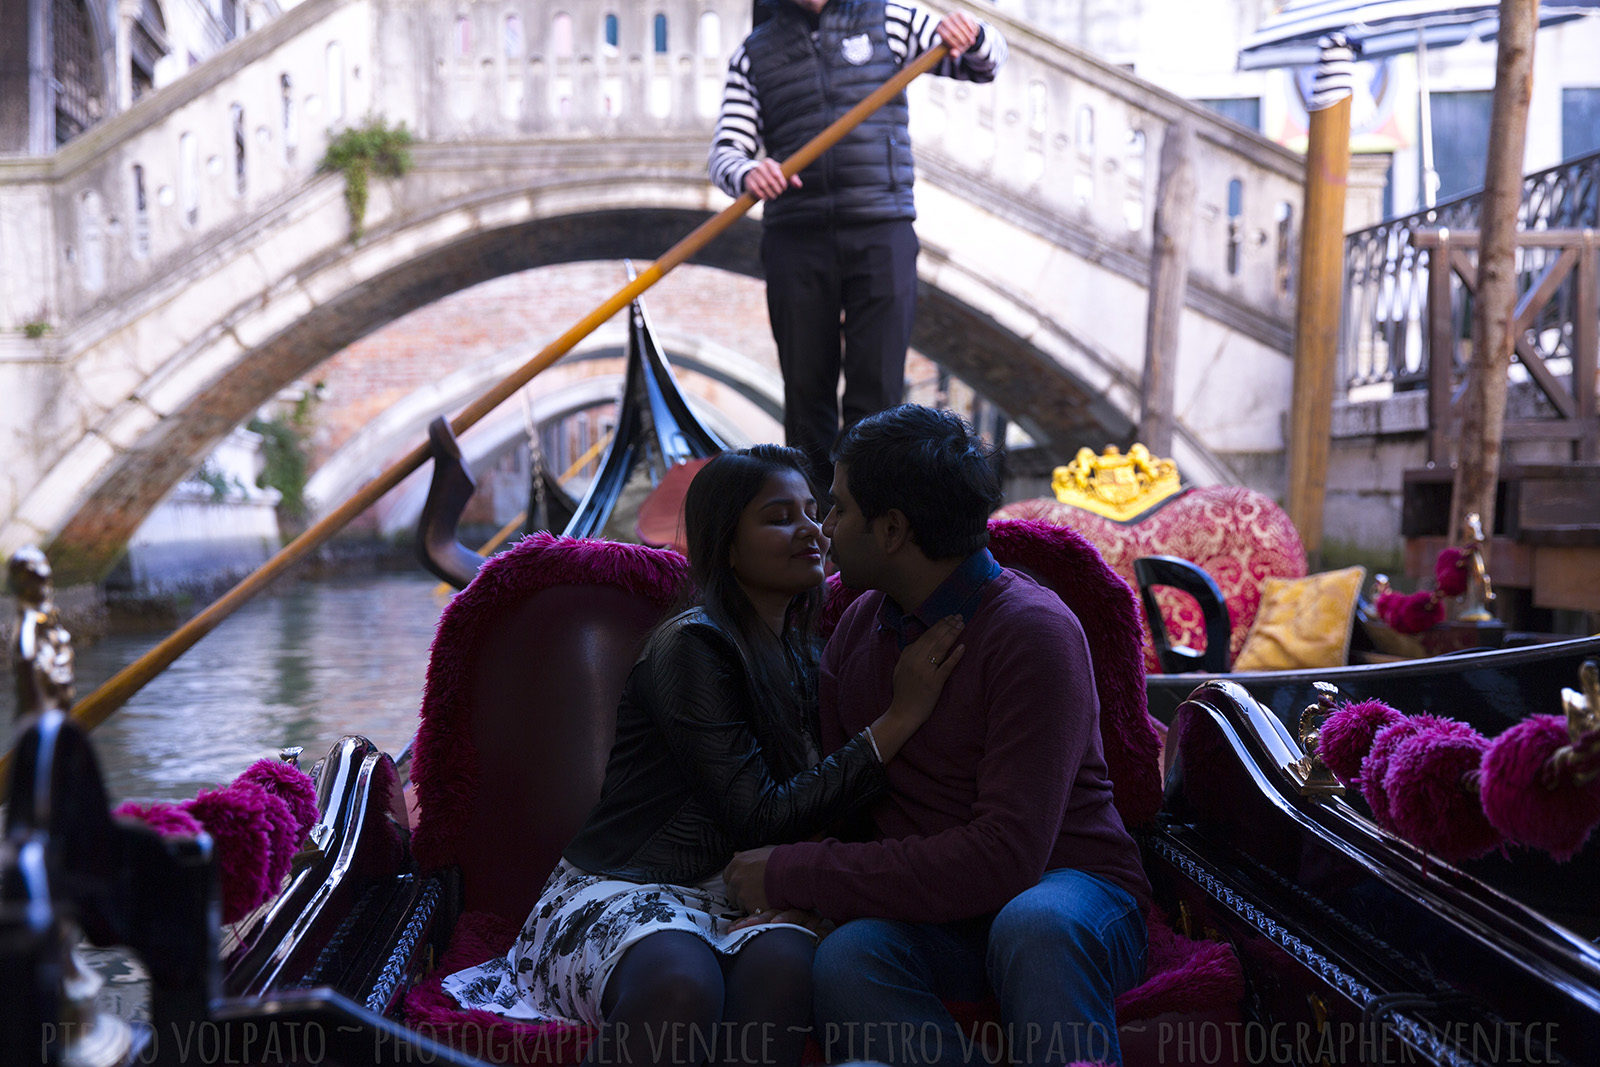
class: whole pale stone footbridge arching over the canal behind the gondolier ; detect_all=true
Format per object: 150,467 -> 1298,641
0,0 -> 1301,579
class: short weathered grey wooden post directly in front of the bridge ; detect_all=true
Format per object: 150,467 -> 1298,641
1139,118 -> 1195,456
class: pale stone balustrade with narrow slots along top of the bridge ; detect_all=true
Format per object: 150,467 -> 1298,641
0,0 -> 1299,342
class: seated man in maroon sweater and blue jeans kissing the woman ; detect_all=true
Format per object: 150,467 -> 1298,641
726,405 -> 1150,1064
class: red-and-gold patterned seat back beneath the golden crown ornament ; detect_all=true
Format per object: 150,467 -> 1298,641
995,485 -> 1306,672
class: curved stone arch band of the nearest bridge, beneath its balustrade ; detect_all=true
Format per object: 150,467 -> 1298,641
37,179 -> 1205,579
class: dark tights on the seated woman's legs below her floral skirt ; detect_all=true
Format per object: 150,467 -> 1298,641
586,929 -> 814,1065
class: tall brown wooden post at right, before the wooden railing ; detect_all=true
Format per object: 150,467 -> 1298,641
1450,0 -> 1539,550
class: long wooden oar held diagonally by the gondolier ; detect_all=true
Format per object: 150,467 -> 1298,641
0,43 -> 949,782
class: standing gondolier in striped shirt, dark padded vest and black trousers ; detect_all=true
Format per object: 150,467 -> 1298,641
710,0 -> 1006,485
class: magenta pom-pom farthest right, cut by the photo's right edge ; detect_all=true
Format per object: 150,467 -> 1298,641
1482,715 -> 1600,862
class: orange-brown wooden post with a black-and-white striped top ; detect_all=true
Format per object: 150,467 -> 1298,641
1288,34 -> 1354,558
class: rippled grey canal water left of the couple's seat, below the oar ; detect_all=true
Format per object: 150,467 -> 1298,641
0,574 -> 446,801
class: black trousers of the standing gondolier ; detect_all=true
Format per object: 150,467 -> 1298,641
762,219 -> 918,494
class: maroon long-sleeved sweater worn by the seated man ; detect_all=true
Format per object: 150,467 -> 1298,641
765,563 -> 1150,923
